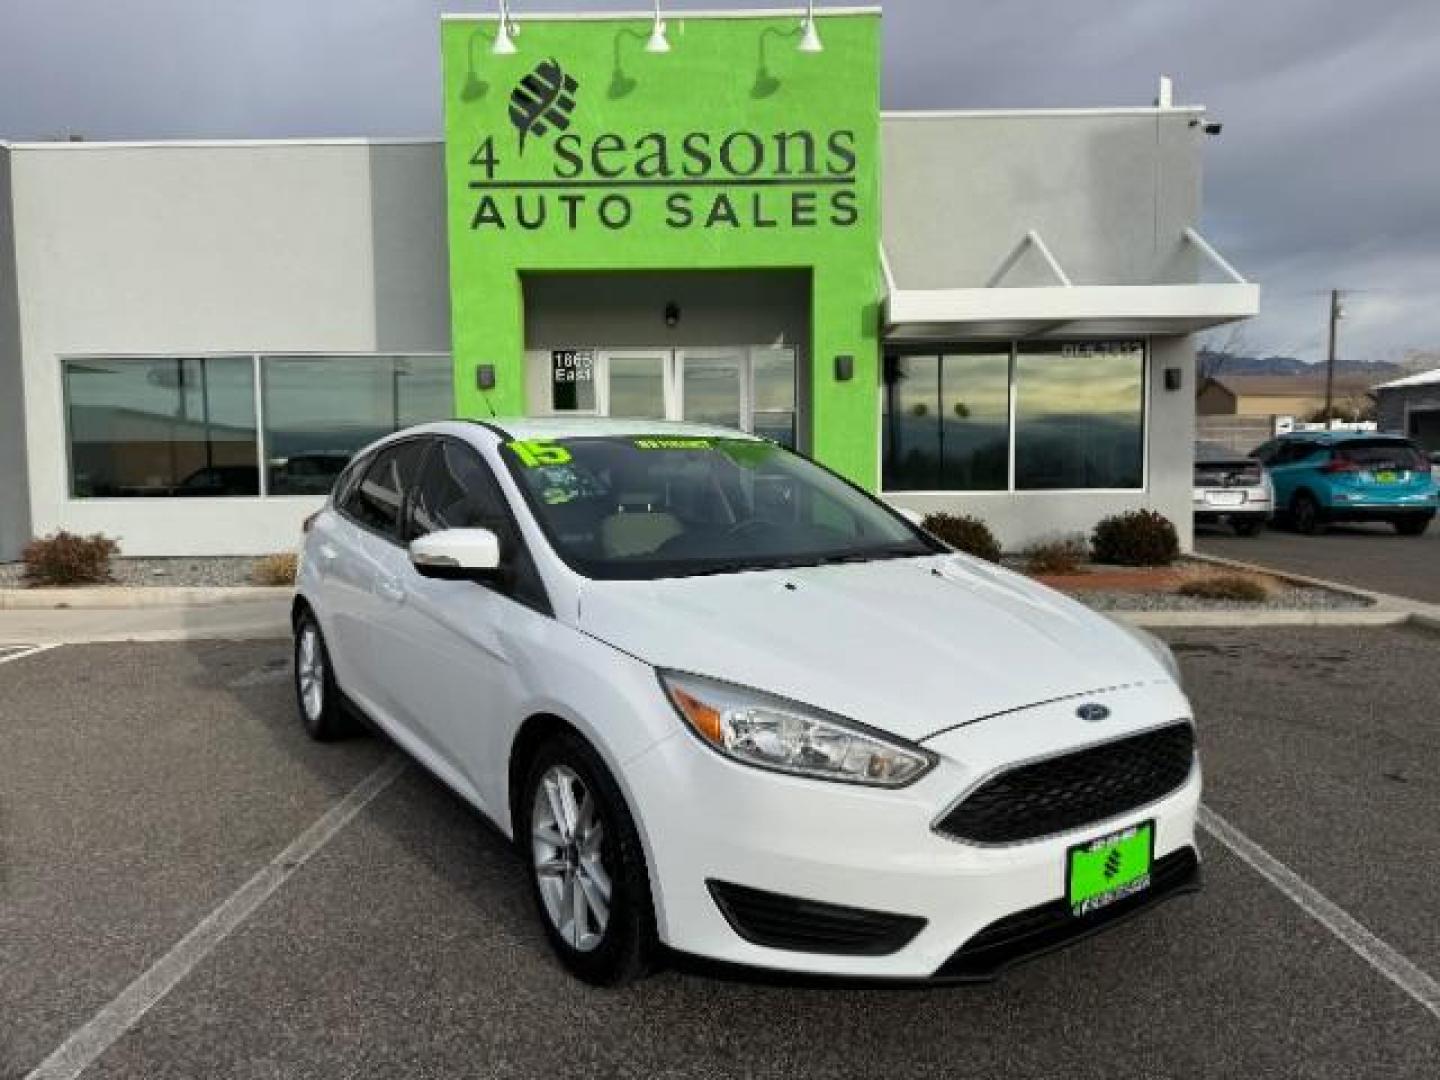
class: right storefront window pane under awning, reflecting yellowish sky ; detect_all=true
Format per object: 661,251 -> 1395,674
1015,341 -> 1145,491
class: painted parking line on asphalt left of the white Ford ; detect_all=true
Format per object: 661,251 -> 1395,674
26,753 -> 405,1080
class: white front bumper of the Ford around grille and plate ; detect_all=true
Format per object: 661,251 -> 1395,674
626,691 -> 1201,979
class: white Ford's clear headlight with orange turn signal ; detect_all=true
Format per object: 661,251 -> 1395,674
660,671 -> 936,788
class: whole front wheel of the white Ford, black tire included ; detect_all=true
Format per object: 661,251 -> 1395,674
516,733 -> 655,986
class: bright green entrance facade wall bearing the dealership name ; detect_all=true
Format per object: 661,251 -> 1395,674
442,9 -> 880,482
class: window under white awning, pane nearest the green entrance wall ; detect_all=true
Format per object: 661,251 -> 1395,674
884,347 -> 1009,491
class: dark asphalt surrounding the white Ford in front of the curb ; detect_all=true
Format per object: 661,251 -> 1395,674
0,629 -> 1440,1079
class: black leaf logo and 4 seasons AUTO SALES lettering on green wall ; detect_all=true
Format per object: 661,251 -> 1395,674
469,58 -> 861,232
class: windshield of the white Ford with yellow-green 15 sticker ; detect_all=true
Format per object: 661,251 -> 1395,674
501,435 -> 945,579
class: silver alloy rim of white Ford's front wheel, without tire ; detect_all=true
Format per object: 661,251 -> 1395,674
530,765 -> 612,952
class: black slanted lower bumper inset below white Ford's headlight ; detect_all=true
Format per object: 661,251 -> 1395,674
706,881 -> 924,956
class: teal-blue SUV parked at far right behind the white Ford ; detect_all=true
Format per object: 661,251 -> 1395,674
1251,431 -> 1437,536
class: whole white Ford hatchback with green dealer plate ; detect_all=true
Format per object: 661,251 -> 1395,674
294,420 -> 1200,984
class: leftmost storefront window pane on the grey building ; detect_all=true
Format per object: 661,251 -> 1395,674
63,356 -> 259,498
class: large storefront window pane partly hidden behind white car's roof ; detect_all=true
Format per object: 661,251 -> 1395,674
261,356 -> 455,495
